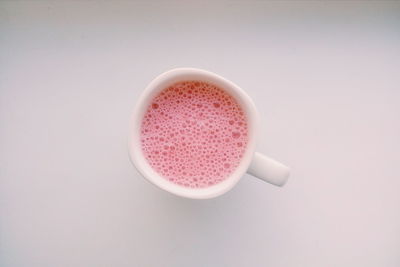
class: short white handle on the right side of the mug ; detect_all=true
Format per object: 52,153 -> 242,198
247,152 -> 290,186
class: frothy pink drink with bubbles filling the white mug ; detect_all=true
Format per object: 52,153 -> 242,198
141,81 -> 248,188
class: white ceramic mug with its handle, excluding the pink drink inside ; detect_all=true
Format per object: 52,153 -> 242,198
129,68 -> 289,199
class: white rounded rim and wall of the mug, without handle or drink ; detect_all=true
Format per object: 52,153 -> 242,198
128,68 -> 259,199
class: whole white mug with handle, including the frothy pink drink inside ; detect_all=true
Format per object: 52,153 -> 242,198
129,68 -> 289,199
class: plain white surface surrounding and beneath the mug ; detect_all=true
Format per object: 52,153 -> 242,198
0,1 -> 400,267
